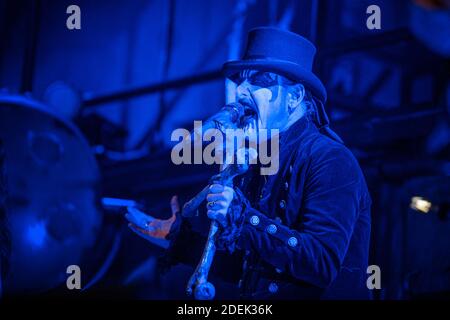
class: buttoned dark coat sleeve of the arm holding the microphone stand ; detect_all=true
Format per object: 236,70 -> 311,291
238,145 -> 362,287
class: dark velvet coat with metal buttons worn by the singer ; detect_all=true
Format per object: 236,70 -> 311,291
163,118 -> 371,299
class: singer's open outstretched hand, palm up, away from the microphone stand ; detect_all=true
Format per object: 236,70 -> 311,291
125,196 -> 180,240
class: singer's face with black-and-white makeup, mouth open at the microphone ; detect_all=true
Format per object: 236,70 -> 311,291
233,70 -> 289,130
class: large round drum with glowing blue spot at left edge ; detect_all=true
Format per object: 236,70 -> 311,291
0,95 -> 103,295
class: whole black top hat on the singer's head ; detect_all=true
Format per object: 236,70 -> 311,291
223,27 -> 327,103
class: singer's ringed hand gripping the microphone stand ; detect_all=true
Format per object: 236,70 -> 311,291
206,184 -> 234,227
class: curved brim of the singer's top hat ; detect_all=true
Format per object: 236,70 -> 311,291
222,59 -> 327,103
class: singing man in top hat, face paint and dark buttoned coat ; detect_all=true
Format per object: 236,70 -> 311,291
126,27 -> 371,299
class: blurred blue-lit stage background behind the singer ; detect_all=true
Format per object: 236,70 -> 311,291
0,0 -> 450,299
